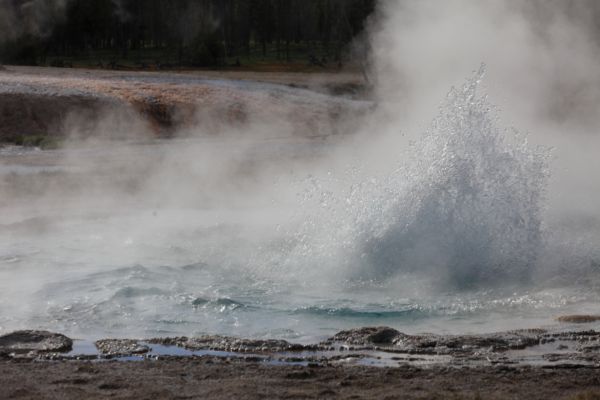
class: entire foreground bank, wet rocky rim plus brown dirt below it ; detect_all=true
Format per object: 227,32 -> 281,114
0,324 -> 600,400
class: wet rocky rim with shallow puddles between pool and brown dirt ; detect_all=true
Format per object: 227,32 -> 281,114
5,324 -> 600,368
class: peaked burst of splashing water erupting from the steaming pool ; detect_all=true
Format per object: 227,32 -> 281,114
284,65 -> 548,289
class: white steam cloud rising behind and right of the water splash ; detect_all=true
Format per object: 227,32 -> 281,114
371,0 -> 600,231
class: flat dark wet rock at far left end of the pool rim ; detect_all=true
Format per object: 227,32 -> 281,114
0,330 -> 73,353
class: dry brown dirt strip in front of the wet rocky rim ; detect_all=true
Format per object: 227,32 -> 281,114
0,357 -> 600,400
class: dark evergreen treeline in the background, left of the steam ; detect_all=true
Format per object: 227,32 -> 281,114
0,0 -> 376,68
